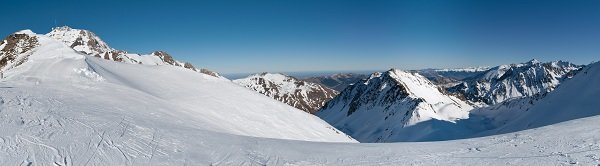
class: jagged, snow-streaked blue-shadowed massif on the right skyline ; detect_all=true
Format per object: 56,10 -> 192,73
448,60 -> 581,105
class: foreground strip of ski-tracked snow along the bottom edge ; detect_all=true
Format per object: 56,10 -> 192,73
0,87 -> 600,165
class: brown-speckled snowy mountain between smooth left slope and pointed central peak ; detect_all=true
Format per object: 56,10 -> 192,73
233,73 -> 337,113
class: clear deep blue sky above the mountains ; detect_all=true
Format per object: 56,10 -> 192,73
0,0 -> 600,73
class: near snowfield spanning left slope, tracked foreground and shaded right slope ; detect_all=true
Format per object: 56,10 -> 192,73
0,29 -> 600,165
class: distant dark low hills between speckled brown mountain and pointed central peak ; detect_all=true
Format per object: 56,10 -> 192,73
302,73 -> 368,91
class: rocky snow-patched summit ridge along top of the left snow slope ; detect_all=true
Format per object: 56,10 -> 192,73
46,26 -> 224,78
